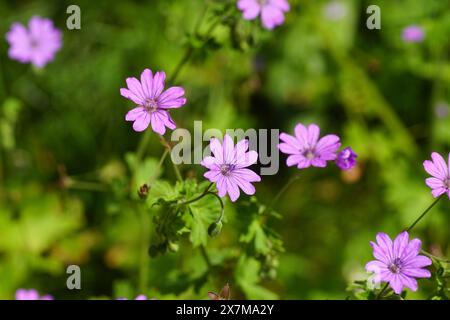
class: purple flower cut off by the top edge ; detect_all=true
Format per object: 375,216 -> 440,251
237,0 -> 290,30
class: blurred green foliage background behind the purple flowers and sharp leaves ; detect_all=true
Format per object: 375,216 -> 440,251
0,0 -> 450,299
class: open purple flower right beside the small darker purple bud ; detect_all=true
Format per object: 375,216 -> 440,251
278,123 -> 341,169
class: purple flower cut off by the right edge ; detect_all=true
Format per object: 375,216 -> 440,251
423,152 -> 450,199
